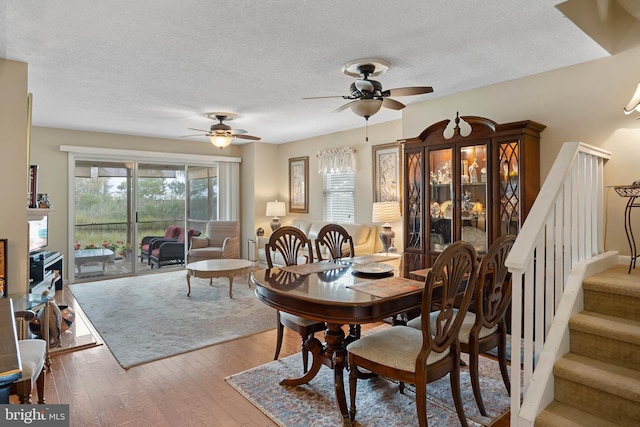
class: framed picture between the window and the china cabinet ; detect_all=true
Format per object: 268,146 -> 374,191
371,142 -> 402,206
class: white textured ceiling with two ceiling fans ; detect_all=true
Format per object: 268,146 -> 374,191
0,0 -> 608,143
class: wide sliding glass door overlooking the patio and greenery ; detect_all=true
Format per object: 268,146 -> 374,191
69,153 -> 240,281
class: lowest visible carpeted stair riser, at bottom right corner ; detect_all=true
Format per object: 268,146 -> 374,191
555,375 -> 640,427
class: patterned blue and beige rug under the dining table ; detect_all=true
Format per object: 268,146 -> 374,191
225,353 -> 510,427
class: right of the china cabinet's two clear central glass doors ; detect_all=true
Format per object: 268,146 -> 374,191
458,144 -> 489,253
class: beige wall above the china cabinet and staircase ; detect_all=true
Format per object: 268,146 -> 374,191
402,44 -> 640,255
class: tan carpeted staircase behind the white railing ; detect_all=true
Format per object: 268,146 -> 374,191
535,265 -> 640,427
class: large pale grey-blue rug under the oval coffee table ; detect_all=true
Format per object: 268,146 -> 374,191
69,270 -> 276,369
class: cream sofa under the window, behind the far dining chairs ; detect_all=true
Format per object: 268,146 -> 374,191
256,219 -> 378,265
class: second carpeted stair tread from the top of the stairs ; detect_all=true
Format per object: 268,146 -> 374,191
569,311 -> 640,345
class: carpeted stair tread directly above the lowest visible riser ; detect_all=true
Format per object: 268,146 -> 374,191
553,353 -> 640,404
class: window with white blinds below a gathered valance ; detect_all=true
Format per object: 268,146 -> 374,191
322,172 -> 355,223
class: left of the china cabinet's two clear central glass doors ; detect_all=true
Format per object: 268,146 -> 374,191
426,148 -> 454,251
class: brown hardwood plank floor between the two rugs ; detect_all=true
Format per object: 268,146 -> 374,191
33,290 -> 509,427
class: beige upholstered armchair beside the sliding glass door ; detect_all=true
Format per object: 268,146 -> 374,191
187,221 -> 240,263
